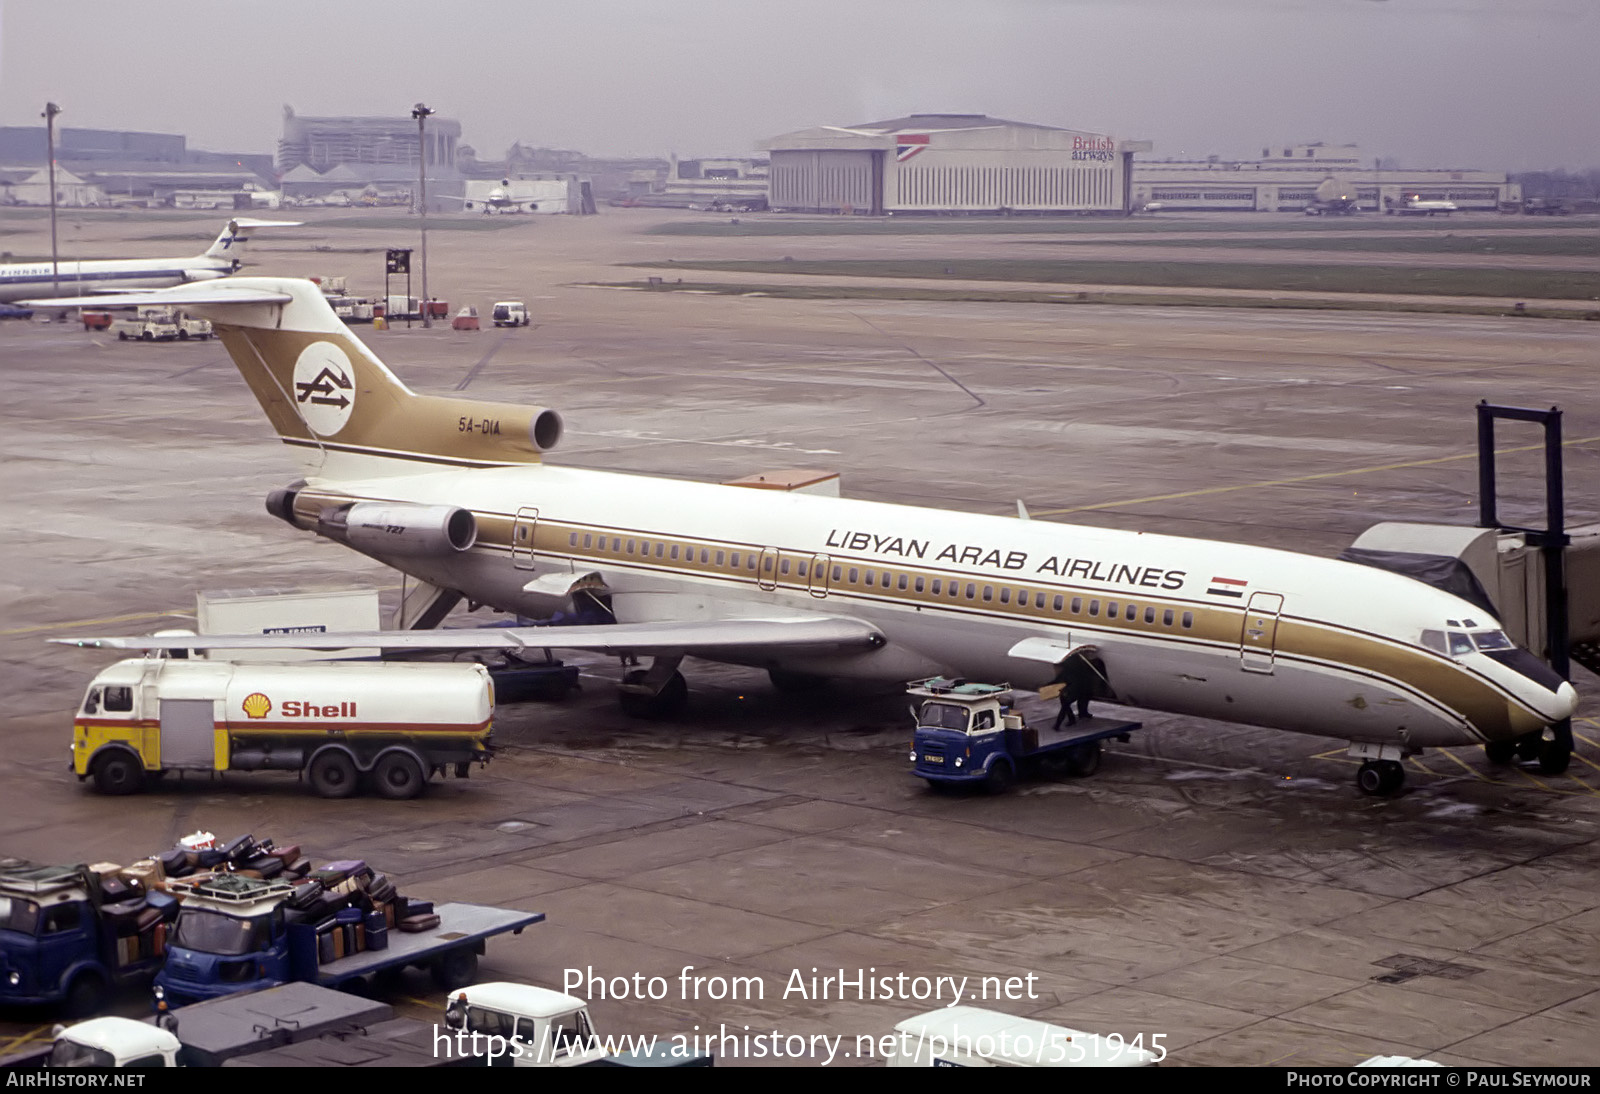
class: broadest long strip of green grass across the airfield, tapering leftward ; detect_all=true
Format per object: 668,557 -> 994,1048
634,259 -> 1600,301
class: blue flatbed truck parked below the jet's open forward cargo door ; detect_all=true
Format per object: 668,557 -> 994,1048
906,677 -> 1141,793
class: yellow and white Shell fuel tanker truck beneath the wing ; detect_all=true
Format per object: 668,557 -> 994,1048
72,654 -> 494,798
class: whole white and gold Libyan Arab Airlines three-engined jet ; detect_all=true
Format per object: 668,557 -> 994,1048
37,278 -> 1576,793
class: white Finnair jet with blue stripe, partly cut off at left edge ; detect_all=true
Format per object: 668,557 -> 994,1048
0,218 -> 299,304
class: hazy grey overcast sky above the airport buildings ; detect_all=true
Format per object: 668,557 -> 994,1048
0,0 -> 1600,171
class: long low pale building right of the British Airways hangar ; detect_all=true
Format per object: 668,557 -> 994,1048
1133,142 -> 1522,213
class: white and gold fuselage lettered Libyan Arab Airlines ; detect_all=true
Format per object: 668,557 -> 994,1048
307,465 -> 1571,747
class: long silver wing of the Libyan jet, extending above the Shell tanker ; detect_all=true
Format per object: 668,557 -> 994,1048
50,616 -> 885,656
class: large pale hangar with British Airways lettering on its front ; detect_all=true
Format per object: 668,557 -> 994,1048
760,114 -> 1150,216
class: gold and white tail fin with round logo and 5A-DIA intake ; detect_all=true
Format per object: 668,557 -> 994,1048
171,277 -> 562,478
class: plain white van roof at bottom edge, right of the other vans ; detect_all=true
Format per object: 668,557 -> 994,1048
888,1006 -> 1166,1067
